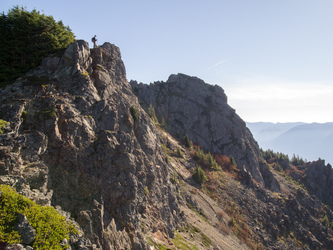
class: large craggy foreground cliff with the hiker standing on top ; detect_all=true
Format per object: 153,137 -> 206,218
0,41 -> 180,249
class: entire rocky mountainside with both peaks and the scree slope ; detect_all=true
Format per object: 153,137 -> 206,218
0,40 -> 333,249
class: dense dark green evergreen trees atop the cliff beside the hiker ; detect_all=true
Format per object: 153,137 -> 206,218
0,6 -> 75,87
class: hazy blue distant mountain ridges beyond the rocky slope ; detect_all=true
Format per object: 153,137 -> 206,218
246,122 -> 333,164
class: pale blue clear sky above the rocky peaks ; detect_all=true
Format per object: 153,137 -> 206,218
0,0 -> 333,123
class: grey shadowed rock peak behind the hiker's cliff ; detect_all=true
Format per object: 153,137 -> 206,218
130,74 -> 265,187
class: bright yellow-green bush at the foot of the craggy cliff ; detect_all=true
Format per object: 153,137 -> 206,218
0,185 -> 77,249
